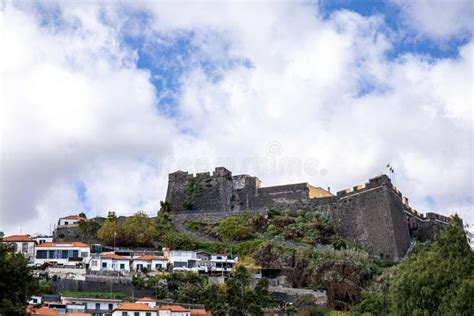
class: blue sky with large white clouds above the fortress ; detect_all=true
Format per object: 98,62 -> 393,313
0,0 -> 474,234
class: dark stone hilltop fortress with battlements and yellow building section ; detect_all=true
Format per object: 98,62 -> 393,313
166,167 -> 449,260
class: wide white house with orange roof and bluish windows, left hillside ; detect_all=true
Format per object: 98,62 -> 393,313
35,241 -> 90,266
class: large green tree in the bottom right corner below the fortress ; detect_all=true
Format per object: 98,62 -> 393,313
389,216 -> 474,315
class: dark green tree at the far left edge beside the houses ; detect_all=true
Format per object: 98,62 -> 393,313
0,243 -> 39,315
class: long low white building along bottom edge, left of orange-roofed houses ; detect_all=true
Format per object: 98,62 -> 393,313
62,296 -> 122,315
